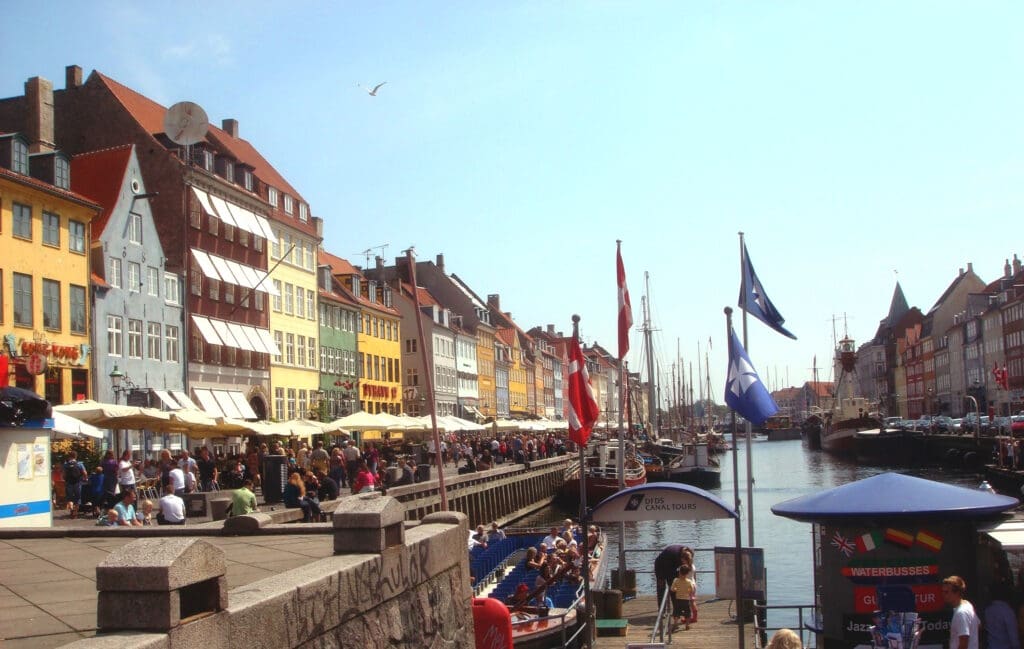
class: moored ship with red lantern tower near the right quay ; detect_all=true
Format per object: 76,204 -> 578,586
821,336 -> 882,458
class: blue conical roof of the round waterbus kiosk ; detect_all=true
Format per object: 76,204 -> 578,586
771,473 -> 1019,522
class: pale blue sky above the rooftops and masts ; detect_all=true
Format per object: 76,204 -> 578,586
0,0 -> 1024,402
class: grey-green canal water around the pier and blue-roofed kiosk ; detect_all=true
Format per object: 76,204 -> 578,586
515,439 -> 982,626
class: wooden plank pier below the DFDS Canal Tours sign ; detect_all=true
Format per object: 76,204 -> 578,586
594,595 -> 757,649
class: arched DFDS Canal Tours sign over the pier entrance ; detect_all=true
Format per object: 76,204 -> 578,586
591,482 -> 736,523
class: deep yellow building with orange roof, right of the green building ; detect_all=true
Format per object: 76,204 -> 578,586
324,255 -> 402,415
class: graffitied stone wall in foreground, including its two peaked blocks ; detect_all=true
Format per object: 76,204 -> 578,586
68,495 -> 474,649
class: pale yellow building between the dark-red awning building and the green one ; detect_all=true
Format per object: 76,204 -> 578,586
269,220 -> 319,421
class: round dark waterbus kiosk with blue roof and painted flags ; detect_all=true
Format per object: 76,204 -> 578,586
772,473 -> 1017,649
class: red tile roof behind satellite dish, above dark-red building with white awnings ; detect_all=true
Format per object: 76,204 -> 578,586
93,71 -> 302,201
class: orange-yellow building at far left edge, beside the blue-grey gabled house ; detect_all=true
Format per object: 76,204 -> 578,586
0,148 -> 100,404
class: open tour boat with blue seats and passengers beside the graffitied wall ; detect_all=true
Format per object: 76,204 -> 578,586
470,528 -> 607,649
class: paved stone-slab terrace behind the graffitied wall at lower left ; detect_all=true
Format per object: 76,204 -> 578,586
0,529 -> 334,649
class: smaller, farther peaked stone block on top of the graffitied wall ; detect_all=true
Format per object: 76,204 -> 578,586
334,493 -> 406,555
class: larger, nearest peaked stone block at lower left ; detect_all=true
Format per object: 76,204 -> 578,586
96,537 -> 227,633
